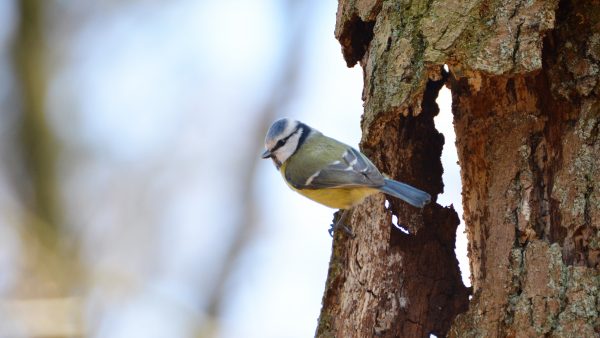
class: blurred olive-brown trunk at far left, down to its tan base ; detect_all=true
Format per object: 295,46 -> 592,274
0,0 -> 83,336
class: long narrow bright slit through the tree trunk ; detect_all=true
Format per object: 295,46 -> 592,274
434,74 -> 471,287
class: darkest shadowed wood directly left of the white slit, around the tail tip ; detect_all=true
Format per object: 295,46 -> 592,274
388,69 -> 470,336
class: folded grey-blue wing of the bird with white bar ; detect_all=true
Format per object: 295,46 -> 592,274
295,147 -> 384,189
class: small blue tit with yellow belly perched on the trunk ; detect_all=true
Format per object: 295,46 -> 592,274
261,118 -> 431,236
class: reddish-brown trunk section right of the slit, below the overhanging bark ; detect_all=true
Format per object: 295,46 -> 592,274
451,1 -> 600,337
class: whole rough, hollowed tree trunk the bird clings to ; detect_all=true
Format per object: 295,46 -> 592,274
317,0 -> 600,337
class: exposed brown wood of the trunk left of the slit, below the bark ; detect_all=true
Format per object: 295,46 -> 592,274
317,69 -> 469,337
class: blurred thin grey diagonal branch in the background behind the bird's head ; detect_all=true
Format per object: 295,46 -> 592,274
205,0 -> 313,331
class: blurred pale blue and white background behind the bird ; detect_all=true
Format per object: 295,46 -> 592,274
0,0 -> 466,338
